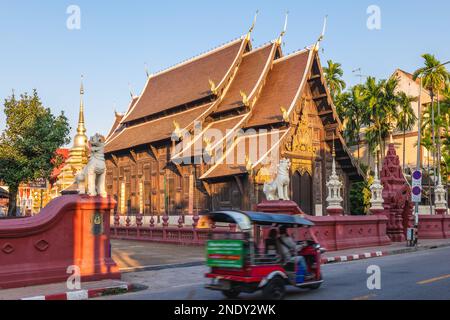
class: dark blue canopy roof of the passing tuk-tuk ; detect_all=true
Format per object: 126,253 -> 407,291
208,210 -> 314,230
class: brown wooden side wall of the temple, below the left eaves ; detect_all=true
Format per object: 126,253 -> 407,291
106,147 -> 208,216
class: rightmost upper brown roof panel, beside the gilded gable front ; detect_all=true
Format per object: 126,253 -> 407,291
246,50 -> 310,127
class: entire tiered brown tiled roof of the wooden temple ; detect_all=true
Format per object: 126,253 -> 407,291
105,35 -> 363,180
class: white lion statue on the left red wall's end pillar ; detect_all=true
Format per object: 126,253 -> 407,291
75,133 -> 106,197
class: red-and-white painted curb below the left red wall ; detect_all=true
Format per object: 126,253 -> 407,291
20,284 -> 133,300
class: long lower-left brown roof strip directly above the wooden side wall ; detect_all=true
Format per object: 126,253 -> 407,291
105,103 -> 211,153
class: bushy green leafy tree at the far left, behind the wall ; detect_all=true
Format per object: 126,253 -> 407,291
0,90 -> 70,216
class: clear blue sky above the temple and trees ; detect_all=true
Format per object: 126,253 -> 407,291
0,0 -> 450,142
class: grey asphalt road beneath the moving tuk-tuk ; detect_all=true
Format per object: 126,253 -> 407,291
103,247 -> 450,300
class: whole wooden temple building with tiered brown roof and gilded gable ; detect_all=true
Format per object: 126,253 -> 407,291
105,28 -> 363,217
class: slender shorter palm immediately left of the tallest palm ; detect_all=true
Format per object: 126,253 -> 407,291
396,92 -> 417,172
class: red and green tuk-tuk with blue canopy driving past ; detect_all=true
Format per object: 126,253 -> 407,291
205,210 -> 325,300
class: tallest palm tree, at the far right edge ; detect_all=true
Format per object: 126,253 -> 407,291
413,53 -> 450,182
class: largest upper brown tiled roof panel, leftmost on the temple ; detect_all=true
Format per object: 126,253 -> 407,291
123,38 -> 247,122
